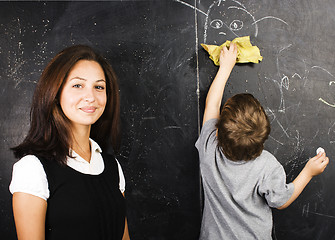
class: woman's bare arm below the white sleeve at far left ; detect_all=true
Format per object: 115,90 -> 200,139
13,192 -> 47,240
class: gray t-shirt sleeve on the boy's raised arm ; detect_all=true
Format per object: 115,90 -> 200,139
195,118 -> 218,158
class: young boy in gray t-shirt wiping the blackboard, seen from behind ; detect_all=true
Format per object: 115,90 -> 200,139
196,44 -> 329,240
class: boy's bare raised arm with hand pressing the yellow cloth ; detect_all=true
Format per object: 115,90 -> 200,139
202,43 -> 237,124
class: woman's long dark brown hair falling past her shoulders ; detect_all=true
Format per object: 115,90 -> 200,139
12,45 -> 120,164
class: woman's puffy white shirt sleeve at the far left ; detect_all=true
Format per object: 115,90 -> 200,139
9,155 -> 50,200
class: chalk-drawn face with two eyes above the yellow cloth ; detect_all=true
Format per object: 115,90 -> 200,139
204,0 -> 258,45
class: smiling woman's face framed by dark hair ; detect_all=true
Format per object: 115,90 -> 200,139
60,60 -> 107,127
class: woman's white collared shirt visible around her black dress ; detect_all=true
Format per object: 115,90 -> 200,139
9,139 -> 125,200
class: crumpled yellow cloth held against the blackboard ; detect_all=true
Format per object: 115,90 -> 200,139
201,36 -> 263,66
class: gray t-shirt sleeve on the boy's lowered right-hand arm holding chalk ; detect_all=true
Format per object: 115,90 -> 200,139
259,162 -> 294,208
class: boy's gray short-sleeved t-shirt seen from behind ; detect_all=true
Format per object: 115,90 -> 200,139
195,119 -> 294,240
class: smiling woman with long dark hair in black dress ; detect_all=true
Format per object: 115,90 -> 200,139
10,45 -> 129,240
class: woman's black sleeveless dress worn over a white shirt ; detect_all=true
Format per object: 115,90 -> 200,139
40,154 -> 126,240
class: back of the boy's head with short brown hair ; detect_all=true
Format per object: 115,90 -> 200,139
216,93 -> 270,161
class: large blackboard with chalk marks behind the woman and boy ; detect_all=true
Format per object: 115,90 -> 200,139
0,0 -> 335,239
